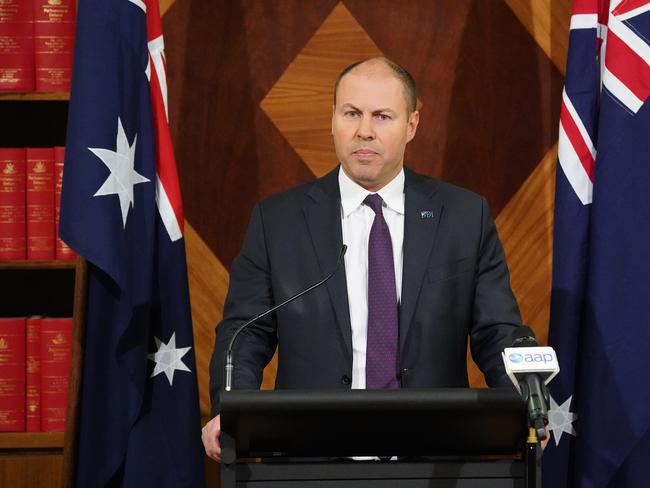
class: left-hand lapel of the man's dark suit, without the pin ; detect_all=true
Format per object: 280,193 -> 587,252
303,167 -> 352,364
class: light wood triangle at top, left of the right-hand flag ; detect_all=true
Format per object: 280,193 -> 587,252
504,0 -> 571,73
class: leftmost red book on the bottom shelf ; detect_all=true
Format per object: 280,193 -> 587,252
0,317 -> 25,432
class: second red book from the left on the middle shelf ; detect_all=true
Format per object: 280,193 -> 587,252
27,147 -> 54,259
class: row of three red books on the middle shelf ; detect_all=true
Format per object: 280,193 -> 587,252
0,147 -> 76,261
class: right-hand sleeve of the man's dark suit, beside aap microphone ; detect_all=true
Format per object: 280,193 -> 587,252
470,199 -> 521,386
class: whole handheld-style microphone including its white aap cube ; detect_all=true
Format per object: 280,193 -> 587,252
502,326 -> 560,440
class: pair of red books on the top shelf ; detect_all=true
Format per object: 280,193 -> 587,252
0,0 -> 76,92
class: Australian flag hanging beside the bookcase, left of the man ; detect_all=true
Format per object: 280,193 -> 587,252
60,0 -> 204,487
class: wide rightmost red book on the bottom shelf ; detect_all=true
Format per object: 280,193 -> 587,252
41,317 -> 72,432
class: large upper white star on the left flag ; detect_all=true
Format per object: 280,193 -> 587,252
88,117 -> 149,228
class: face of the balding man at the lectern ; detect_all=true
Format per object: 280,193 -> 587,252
332,63 -> 419,191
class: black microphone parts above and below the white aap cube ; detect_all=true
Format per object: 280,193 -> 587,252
511,325 -> 549,440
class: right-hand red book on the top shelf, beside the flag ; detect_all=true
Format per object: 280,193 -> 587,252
32,0 -> 76,91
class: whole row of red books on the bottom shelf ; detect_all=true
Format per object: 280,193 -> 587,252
0,317 -> 72,432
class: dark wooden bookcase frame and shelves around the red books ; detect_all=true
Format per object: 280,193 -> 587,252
0,92 -> 87,488
